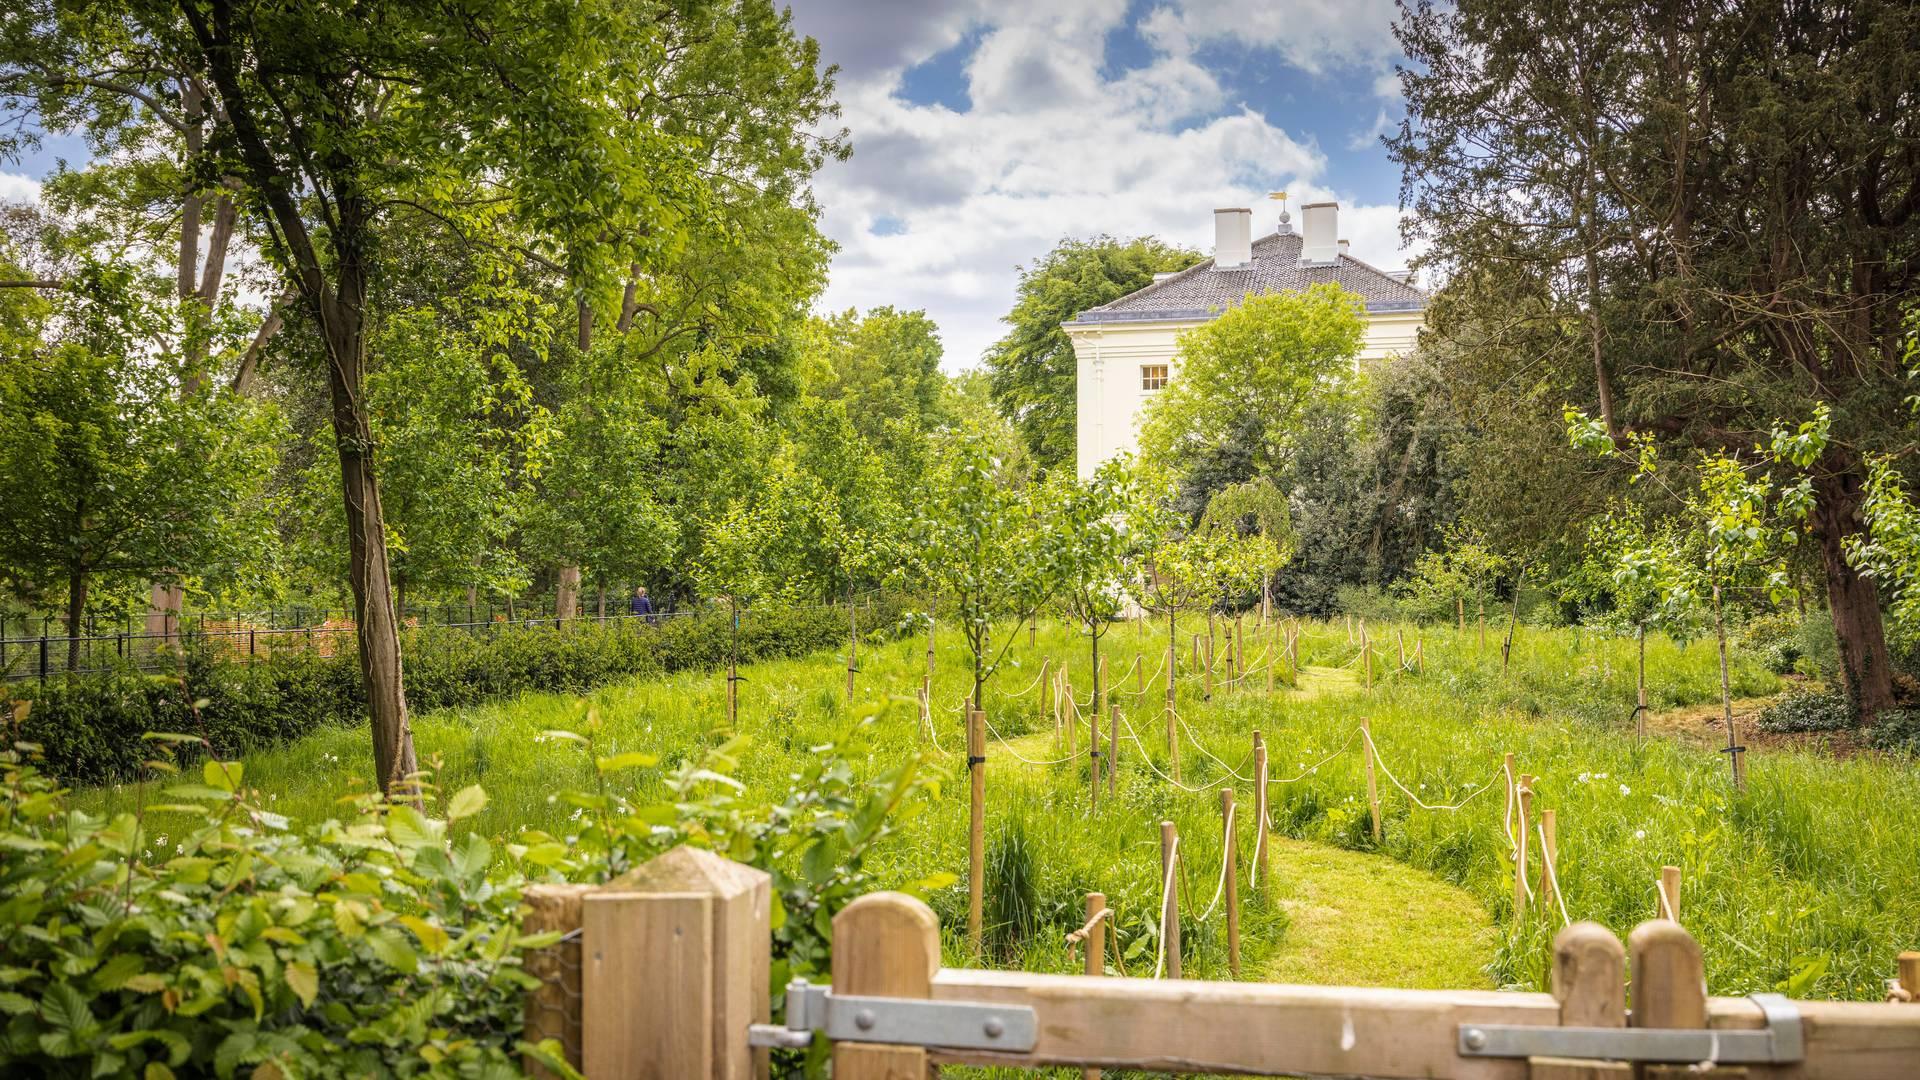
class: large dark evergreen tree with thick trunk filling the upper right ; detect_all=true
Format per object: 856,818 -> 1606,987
1392,0 -> 1920,713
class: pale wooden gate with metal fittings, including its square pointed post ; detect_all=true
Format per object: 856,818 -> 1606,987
528,847 -> 1920,1080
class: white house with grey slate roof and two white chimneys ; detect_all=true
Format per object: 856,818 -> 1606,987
1066,202 -> 1427,480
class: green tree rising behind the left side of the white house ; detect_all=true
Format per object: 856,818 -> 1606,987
987,236 -> 1200,473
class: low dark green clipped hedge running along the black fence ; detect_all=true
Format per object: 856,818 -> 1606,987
10,600 -> 900,784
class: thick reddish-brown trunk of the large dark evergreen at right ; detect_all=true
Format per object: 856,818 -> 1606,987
1812,463 -> 1893,723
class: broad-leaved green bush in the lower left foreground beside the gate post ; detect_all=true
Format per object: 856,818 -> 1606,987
0,718 -> 555,1080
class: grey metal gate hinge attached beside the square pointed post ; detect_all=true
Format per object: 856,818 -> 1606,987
747,978 -> 1039,1053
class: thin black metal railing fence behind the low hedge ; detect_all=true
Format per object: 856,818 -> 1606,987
0,605 -> 693,682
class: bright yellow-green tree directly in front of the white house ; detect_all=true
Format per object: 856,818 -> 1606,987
1140,282 -> 1367,480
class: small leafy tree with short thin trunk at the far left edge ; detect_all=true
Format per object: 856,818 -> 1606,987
0,269 -> 273,669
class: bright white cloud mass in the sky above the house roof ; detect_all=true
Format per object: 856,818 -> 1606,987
803,0 -> 1428,371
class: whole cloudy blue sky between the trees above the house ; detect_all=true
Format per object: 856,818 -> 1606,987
791,0 -> 1409,371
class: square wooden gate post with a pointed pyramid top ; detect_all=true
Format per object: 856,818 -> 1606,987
580,846 -> 774,1080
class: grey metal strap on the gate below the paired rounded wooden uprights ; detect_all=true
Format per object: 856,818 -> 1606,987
1459,994 -> 1807,1065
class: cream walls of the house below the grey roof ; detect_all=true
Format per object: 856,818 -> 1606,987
1068,311 -> 1423,480
